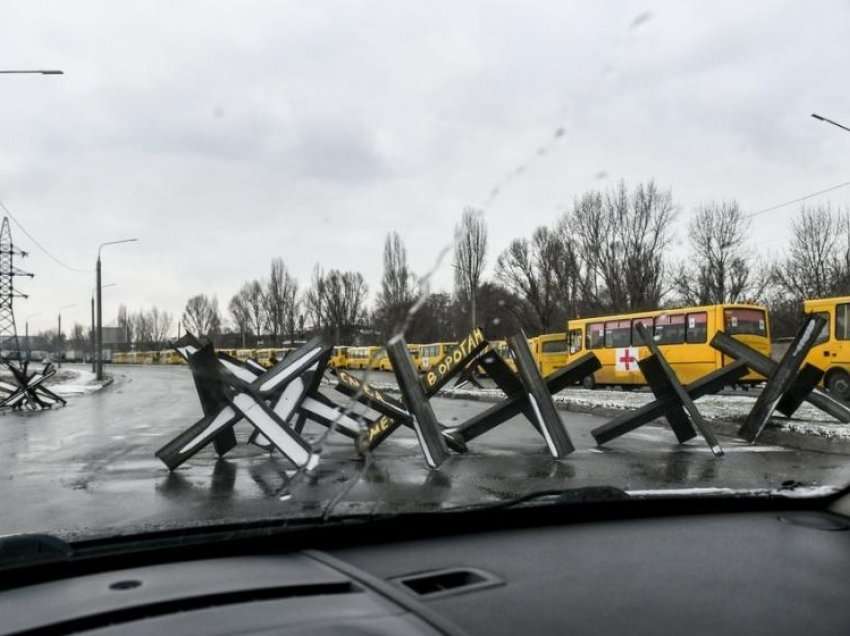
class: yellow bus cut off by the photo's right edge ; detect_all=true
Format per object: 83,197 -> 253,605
803,296 -> 850,400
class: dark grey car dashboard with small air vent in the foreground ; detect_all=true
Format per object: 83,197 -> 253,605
0,496 -> 850,636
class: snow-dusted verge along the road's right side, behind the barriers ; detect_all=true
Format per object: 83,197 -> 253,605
372,385 -> 850,455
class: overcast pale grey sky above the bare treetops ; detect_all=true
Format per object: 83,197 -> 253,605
0,0 -> 850,333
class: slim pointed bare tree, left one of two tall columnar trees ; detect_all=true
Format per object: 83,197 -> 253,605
374,232 -> 416,338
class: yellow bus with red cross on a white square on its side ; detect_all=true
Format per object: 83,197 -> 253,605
567,304 -> 770,388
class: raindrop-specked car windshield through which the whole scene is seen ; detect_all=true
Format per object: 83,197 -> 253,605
0,0 -> 850,538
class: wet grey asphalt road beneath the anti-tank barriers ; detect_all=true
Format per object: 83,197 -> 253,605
0,366 -> 850,538
